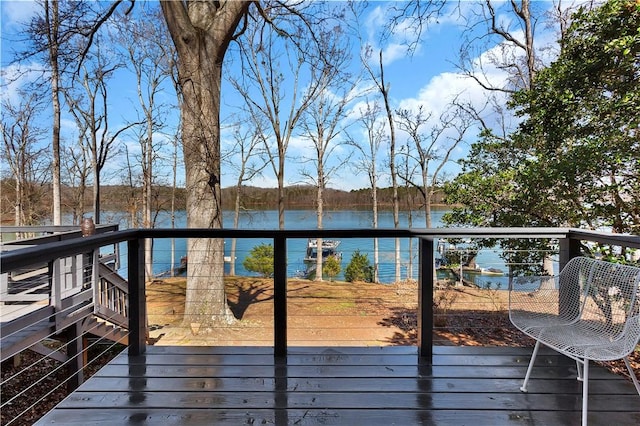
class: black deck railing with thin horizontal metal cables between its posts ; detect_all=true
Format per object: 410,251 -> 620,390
1,228 -> 640,424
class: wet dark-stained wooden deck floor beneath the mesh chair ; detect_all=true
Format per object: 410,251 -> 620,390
38,346 -> 640,426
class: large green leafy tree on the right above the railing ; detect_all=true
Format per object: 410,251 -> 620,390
445,0 -> 640,249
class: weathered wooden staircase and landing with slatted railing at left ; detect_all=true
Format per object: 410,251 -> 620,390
0,238 -> 129,361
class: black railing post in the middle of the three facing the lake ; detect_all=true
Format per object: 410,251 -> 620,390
273,236 -> 287,357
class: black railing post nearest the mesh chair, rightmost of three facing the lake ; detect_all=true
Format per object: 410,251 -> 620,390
418,238 -> 435,363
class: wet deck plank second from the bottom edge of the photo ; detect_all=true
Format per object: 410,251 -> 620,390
59,389 -> 638,412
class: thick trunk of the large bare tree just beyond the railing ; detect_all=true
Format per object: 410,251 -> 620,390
161,1 -> 249,328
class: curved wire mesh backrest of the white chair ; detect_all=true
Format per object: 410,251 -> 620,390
560,257 -> 640,344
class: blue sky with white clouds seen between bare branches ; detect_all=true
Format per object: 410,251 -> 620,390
0,0 -> 568,190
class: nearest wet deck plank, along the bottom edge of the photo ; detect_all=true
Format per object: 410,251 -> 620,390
38,408 -> 640,426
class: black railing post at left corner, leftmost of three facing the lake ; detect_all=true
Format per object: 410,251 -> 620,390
127,238 -> 147,356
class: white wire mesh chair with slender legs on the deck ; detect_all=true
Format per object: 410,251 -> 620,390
509,257 -> 640,425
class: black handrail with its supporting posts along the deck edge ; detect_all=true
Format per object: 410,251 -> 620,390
0,228 -> 640,360
